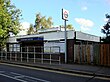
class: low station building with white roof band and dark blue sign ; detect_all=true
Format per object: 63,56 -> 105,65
7,27 -> 100,60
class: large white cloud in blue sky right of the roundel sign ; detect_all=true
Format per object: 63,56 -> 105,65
75,18 -> 94,31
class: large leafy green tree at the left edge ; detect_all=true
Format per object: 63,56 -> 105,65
0,0 -> 21,46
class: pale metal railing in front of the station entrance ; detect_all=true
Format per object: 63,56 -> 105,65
0,46 -> 61,64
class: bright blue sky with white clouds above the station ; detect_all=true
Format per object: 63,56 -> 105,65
11,0 -> 110,36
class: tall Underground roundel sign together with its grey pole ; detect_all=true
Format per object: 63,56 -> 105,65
62,9 -> 69,63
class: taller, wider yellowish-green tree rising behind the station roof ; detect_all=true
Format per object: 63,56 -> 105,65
35,13 -> 53,32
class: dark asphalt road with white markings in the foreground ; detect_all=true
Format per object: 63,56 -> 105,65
0,63 -> 110,82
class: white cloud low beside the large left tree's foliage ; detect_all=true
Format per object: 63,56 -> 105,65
18,22 -> 30,35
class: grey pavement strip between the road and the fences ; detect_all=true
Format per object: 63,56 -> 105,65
1,61 -> 110,78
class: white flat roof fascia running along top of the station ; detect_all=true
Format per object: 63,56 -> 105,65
8,30 -> 100,42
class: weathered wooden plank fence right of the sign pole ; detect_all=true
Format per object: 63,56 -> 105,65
74,44 -> 110,66
